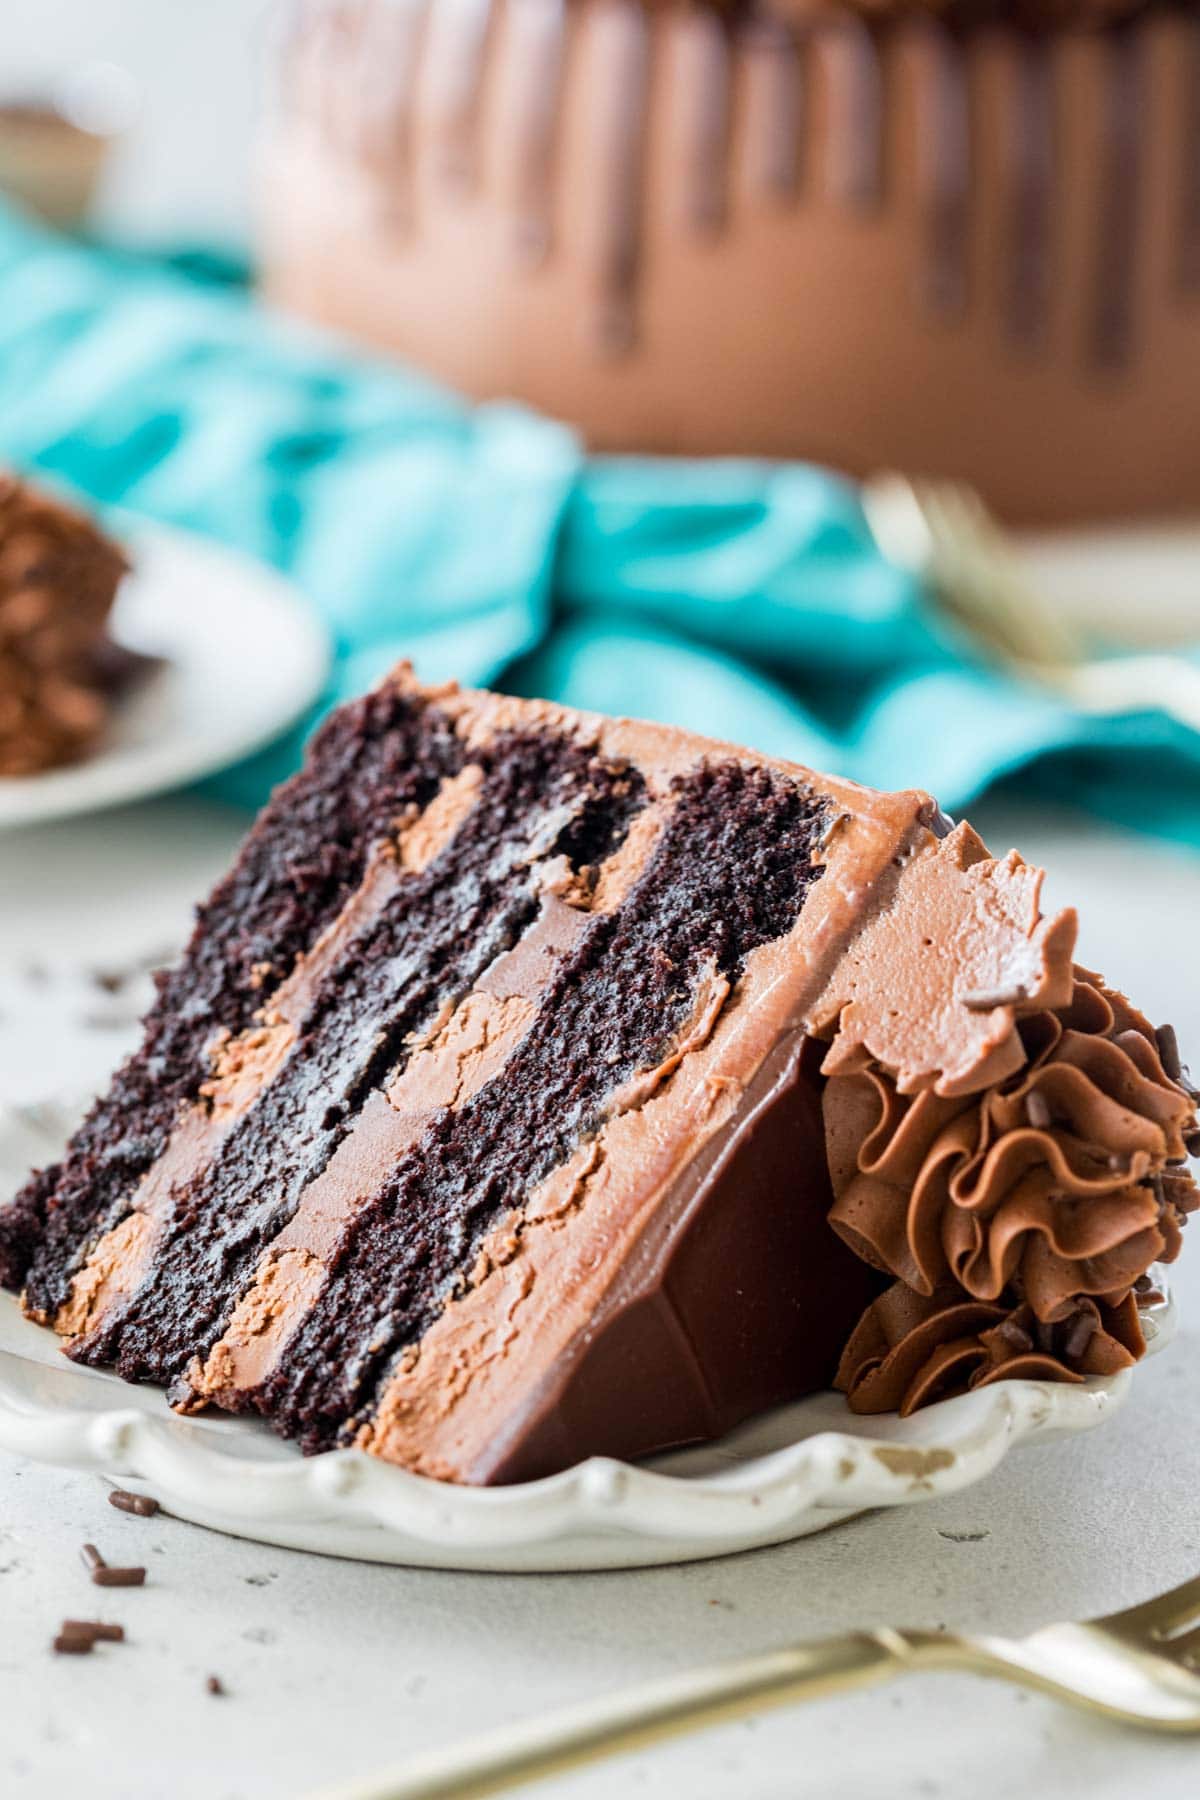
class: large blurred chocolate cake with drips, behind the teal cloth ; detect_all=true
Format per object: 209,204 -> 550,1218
261,0 -> 1200,522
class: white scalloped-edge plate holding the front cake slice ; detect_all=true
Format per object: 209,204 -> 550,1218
0,1109 -> 1175,1570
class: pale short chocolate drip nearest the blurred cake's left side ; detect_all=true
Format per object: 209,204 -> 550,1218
360,0 -> 428,234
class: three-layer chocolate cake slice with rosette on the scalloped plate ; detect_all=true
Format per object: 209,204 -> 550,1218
0,670 -> 1195,1481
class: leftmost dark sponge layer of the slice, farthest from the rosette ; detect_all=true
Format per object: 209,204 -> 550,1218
0,688 -> 462,1318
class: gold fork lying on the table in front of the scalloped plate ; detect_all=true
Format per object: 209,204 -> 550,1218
320,1577 -> 1200,1800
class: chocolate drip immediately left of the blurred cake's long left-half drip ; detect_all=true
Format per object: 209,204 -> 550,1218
506,0 -> 565,265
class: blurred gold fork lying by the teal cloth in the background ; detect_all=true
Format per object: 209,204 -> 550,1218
862,473 -> 1200,731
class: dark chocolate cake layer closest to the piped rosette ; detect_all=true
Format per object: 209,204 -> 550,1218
239,761 -> 826,1449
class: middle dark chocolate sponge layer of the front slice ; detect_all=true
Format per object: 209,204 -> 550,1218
72,733 -> 639,1381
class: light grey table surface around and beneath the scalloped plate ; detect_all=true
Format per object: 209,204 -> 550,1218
0,799 -> 1200,1800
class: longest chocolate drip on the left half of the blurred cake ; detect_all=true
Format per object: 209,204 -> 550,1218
587,0 -> 649,356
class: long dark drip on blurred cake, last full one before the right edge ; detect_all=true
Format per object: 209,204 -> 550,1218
1088,25 -> 1146,369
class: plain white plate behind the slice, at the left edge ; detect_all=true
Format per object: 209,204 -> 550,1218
0,520 -> 329,830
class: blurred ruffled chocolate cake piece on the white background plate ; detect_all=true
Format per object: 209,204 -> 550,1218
0,470 -> 130,776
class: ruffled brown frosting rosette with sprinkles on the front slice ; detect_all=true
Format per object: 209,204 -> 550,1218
824,968 -> 1200,1415
